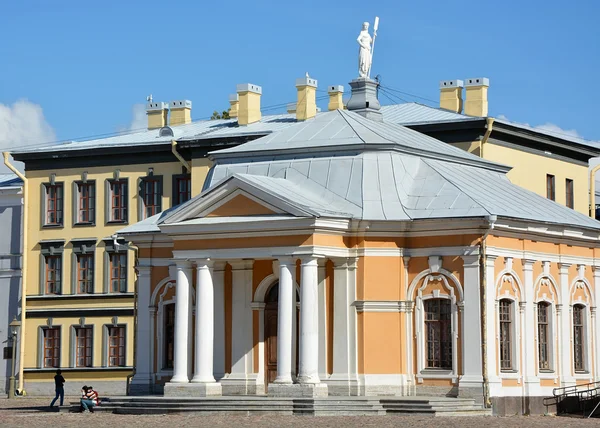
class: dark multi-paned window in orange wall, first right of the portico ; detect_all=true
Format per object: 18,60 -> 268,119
424,299 -> 452,370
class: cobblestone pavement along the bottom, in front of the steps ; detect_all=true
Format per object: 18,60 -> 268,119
0,398 -> 600,428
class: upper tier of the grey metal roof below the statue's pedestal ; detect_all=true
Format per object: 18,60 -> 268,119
211,110 -> 509,171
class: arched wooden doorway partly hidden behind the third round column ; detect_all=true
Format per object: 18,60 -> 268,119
264,282 -> 300,389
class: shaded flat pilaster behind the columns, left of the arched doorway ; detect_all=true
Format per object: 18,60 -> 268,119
227,260 -> 254,388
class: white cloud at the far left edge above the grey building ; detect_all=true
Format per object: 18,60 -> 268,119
0,100 -> 56,173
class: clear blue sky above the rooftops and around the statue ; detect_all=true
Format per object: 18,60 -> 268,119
0,0 -> 600,147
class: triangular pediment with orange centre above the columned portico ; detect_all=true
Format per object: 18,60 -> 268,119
161,175 -> 318,224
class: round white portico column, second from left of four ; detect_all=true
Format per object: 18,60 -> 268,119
192,259 -> 215,383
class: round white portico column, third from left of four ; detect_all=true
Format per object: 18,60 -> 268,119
275,258 -> 296,384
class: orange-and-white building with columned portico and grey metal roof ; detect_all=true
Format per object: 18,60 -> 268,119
119,79 -> 600,414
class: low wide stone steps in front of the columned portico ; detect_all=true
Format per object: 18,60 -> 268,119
70,396 -> 491,416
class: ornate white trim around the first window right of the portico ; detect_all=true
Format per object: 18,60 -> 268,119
416,274 -> 462,383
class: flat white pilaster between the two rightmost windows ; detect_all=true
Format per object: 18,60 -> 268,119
557,263 -> 575,386
